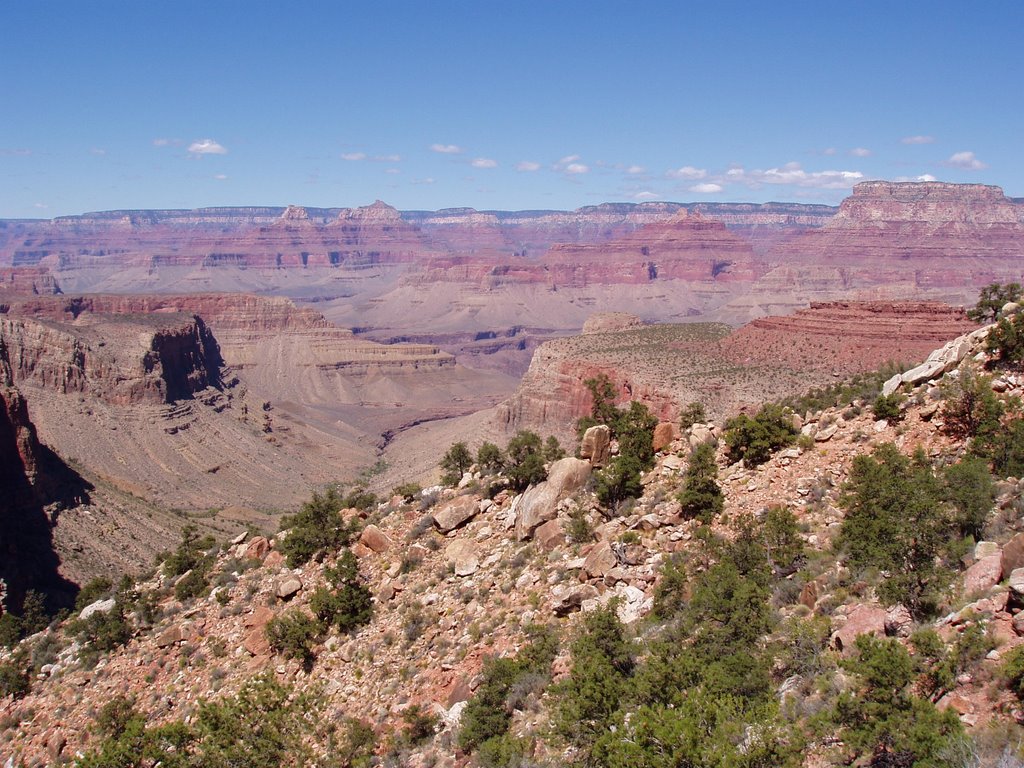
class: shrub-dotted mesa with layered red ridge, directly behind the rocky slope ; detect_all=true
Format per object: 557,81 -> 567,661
497,302 -> 976,438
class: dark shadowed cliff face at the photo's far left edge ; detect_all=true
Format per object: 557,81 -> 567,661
0,343 -> 81,611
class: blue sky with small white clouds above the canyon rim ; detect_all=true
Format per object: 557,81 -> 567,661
0,0 -> 1024,217
